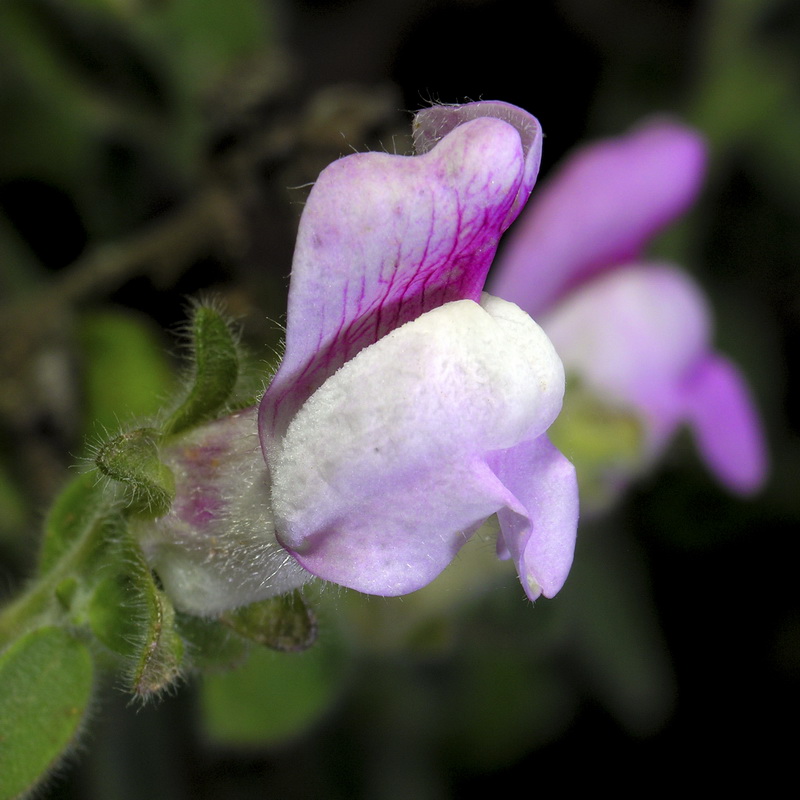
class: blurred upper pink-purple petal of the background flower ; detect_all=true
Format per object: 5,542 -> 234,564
490,120 -> 706,317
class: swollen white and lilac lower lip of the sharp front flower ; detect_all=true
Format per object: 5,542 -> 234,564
271,298 -> 564,595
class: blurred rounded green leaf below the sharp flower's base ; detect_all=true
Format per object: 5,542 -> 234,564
201,630 -> 349,746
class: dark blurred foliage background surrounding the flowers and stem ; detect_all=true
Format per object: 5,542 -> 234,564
0,0 -> 800,800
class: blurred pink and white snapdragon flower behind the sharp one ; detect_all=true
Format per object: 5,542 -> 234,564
491,120 -> 766,494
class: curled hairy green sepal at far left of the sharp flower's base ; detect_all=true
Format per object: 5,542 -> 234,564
95,428 -> 175,517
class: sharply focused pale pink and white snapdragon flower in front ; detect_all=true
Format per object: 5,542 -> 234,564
140,102 -> 578,614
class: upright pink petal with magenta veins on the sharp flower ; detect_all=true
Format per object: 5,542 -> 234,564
259,111 -> 527,452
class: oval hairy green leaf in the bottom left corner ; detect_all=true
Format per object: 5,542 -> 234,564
0,627 -> 92,800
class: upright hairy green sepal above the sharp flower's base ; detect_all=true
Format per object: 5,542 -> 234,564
163,306 -> 239,435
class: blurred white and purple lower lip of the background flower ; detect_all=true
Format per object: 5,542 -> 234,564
540,264 -> 767,493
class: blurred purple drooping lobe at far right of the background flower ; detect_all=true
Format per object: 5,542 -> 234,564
685,355 -> 767,494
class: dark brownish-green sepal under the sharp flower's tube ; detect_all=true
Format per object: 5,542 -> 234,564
219,591 -> 317,653
